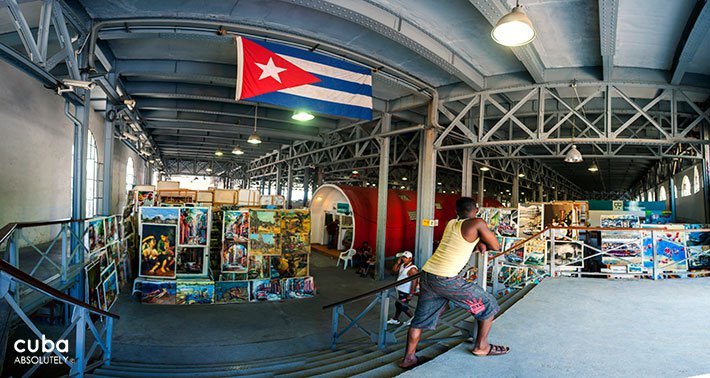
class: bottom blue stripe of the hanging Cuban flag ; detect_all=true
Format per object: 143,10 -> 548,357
249,92 -> 372,119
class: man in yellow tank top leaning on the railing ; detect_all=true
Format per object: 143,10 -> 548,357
400,197 -> 510,369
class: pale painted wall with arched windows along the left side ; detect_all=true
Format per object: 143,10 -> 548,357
0,61 -> 145,242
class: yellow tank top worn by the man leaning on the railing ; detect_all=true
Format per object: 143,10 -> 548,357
422,219 -> 479,277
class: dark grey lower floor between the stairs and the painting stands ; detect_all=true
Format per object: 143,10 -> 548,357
111,252 -> 395,364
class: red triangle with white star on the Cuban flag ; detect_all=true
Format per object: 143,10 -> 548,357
235,37 -> 320,101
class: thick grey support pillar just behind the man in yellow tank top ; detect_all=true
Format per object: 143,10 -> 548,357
415,112 -> 438,266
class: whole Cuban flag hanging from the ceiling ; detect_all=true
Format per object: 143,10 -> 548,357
235,37 -> 372,119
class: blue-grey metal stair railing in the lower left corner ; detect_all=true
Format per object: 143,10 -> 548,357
0,219 -> 119,377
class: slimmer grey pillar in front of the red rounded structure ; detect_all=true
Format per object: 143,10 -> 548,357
375,113 -> 392,280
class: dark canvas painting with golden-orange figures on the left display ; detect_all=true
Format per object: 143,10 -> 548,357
139,224 -> 177,278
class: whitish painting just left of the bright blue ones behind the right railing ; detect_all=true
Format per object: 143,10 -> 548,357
601,230 -> 643,270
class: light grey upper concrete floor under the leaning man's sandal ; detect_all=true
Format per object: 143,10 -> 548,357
402,278 -> 710,378
